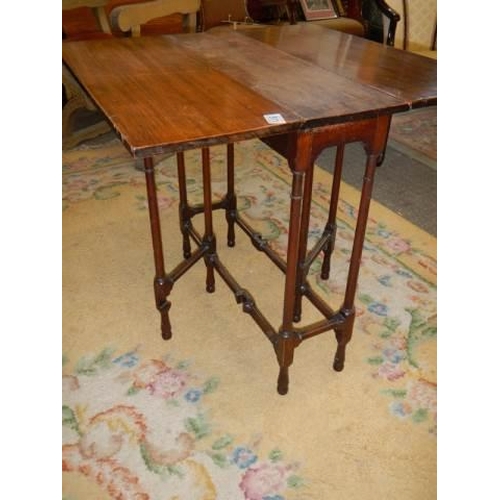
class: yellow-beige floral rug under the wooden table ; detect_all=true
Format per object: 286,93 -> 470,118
62,140 -> 437,500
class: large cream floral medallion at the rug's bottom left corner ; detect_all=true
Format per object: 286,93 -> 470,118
62,349 -> 303,500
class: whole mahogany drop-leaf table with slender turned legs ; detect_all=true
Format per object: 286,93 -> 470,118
63,25 -> 437,394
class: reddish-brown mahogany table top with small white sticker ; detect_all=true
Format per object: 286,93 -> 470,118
63,24 -> 437,157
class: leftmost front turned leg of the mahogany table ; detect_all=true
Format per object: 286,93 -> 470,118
144,158 -> 172,340
